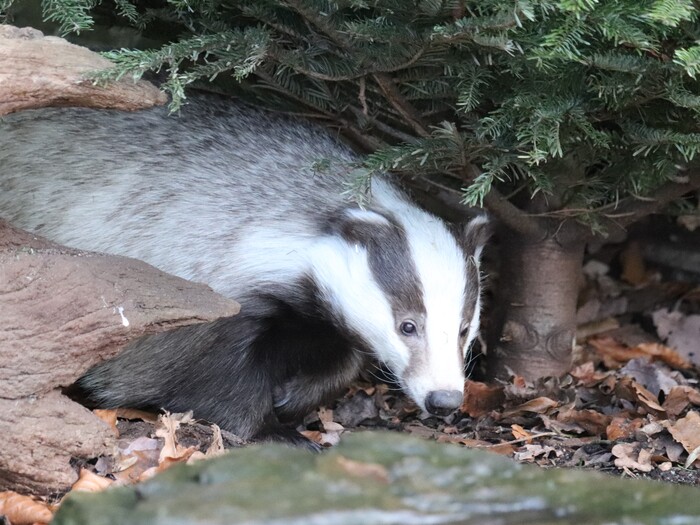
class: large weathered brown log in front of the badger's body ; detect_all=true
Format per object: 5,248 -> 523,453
0,221 -> 239,493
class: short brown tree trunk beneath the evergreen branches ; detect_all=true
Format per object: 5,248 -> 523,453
486,229 -> 585,380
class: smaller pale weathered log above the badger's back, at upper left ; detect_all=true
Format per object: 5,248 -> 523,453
0,25 -> 167,115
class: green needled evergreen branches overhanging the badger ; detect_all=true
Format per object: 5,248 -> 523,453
9,0 -> 700,231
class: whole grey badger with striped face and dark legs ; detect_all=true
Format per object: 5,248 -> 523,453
0,95 -> 488,444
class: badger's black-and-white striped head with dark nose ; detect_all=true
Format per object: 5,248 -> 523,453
314,205 -> 489,415
